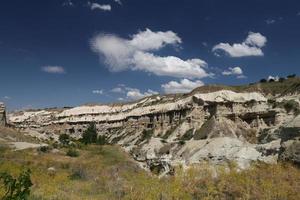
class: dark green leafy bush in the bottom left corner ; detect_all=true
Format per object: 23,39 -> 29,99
0,169 -> 32,200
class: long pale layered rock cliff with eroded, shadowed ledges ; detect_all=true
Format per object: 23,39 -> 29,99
9,90 -> 299,173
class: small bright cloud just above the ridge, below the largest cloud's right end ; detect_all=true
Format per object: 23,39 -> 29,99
161,79 -> 204,93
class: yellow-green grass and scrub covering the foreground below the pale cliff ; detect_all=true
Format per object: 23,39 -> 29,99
0,145 -> 300,200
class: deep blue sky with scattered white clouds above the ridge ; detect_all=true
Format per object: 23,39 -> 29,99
0,0 -> 300,110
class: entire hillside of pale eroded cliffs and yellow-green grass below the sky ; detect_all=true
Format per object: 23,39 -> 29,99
0,78 -> 300,200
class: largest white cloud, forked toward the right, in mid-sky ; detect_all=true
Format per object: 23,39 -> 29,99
91,29 -> 208,78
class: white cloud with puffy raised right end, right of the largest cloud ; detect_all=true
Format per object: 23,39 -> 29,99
212,32 -> 267,57
